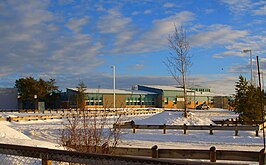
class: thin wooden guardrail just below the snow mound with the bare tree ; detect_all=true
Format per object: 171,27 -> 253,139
113,121 -> 260,136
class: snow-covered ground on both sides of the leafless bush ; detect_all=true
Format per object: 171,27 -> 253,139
0,109 -> 263,151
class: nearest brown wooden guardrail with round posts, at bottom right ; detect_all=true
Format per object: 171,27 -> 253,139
115,145 -> 265,165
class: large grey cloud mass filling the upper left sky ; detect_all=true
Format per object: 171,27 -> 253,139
0,0 -> 103,77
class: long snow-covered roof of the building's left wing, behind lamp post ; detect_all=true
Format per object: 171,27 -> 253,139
67,88 -> 157,95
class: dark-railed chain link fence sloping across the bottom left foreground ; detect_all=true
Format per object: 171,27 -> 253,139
0,144 -> 187,165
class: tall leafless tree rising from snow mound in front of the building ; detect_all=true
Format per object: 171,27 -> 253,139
164,25 -> 192,117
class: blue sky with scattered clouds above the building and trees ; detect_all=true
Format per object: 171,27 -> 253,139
0,0 -> 266,94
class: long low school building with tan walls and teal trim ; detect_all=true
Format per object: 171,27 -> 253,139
61,85 -> 229,109
